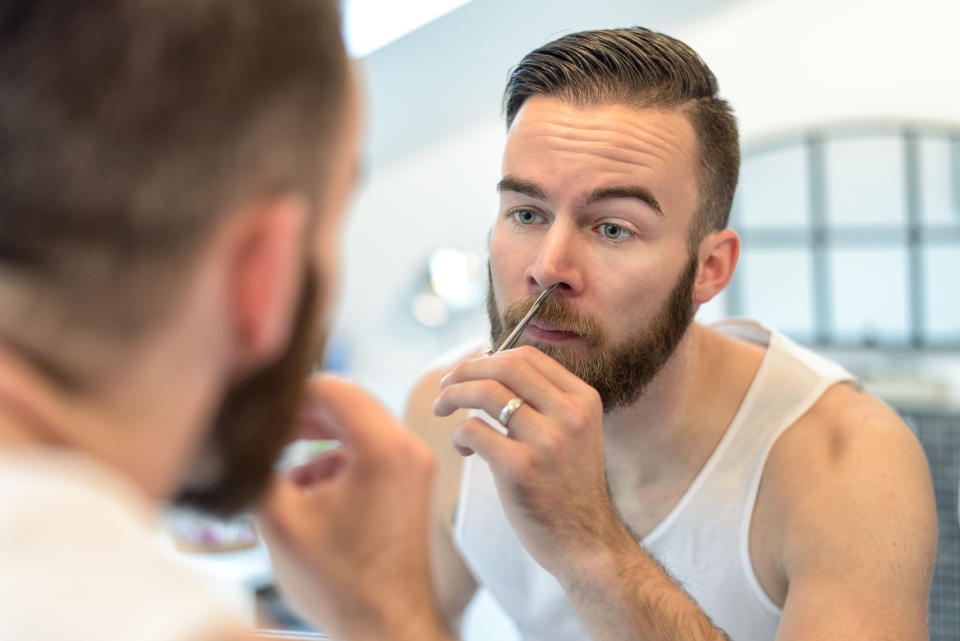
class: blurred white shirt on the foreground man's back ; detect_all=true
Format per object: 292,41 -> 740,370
0,449 -> 238,641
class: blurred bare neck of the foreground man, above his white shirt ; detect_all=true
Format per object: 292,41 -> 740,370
0,330 -> 226,500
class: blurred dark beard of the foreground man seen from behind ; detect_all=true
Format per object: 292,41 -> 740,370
175,269 -> 323,517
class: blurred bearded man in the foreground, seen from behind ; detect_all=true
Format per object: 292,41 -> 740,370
0,0 -> 454,641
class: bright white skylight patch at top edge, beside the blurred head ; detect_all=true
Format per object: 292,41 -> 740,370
343,0 -> 470,58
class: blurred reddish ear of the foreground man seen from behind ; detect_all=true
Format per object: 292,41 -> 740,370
228,195 -> 309,367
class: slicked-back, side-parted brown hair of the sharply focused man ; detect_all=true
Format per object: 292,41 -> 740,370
503,27 -> 740,243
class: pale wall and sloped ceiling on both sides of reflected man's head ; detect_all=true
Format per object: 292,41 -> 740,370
337,0 -> 960,410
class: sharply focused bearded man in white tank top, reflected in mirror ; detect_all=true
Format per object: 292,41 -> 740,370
406,28 -> 936,641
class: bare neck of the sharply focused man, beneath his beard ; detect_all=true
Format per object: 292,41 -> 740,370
603,323 -> 752,494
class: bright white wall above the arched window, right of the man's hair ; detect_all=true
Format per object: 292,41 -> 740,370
682,0 -> 960,144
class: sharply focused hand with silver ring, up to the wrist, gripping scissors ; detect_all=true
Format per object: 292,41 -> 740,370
434,347 -> 636,585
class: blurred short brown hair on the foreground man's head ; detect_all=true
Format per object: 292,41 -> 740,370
0,0 -> 349,379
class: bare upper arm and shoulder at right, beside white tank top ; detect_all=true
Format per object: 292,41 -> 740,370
757,385 -> 937,641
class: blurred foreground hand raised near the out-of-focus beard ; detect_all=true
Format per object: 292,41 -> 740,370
258,377 -> 449,641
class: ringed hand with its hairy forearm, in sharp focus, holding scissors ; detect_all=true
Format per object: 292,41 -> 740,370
434,347 -> 724,641
